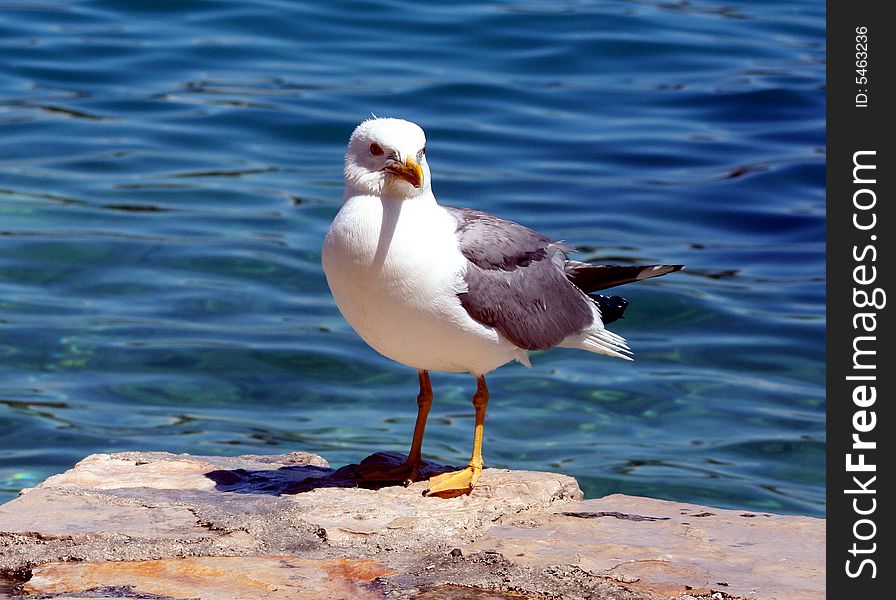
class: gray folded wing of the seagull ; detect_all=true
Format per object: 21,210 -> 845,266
446,206 -> 594,350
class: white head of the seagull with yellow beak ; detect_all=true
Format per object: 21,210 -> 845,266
345,118 -> 432,199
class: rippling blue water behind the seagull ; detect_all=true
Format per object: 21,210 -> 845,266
0,0 -> 825,515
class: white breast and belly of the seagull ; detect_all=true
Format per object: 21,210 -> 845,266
323,195 -> 527,374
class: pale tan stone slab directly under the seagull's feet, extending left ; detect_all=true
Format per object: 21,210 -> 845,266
0,452 -> 582,571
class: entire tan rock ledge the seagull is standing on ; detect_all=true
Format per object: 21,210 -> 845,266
0,452 -> 824,600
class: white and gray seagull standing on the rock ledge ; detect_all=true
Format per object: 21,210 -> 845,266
322,117 -> 683,497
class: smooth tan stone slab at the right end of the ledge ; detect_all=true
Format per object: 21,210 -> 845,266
472,494 -> 825,600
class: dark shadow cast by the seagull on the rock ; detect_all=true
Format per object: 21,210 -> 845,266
205,452 -> 456,496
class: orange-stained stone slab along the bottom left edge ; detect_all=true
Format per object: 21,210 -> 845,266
25,556 -> 394,600
